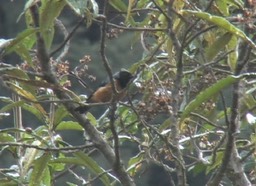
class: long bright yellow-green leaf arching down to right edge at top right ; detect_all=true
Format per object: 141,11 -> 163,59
182,10 -> 256,48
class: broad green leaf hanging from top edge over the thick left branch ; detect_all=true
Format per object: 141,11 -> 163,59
39,0 -> 66,49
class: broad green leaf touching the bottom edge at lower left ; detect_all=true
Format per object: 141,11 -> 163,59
29,153 -> 51,186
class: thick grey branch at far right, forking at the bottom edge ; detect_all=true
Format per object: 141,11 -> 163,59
209,1 -> 252,186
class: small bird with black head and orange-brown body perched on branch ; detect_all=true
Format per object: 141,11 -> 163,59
75,70 -> 134,114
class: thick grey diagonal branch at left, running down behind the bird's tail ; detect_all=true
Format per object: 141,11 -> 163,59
30,5 -> 134,186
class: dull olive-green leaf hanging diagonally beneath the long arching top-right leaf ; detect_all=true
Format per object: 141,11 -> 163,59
205,32 -> 233,61
